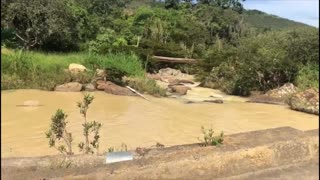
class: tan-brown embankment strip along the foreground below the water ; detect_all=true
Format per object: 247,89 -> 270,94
1,127 -> 319,179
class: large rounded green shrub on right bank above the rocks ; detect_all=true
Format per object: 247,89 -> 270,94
197,29 -> 319,96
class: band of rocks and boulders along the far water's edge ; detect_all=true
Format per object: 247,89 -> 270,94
55,64 -> 319,115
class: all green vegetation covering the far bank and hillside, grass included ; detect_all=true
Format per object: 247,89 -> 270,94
1,0 -> 319,95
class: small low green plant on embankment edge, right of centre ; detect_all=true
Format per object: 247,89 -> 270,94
199,126 -> 223,146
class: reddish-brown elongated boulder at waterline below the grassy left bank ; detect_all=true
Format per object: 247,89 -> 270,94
97,80 -> 136,96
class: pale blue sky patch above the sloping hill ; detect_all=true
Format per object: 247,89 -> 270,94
243,0 -> 319,27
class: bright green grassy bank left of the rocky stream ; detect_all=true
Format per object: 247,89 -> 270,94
1,48 -> 163,95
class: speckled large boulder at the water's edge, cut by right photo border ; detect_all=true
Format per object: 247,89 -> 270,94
289,88 -> 319,115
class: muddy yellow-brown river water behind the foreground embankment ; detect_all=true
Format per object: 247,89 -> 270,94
1,89 -> 319,157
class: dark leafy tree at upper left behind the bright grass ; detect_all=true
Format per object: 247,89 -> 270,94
6,0 -> 72,49
